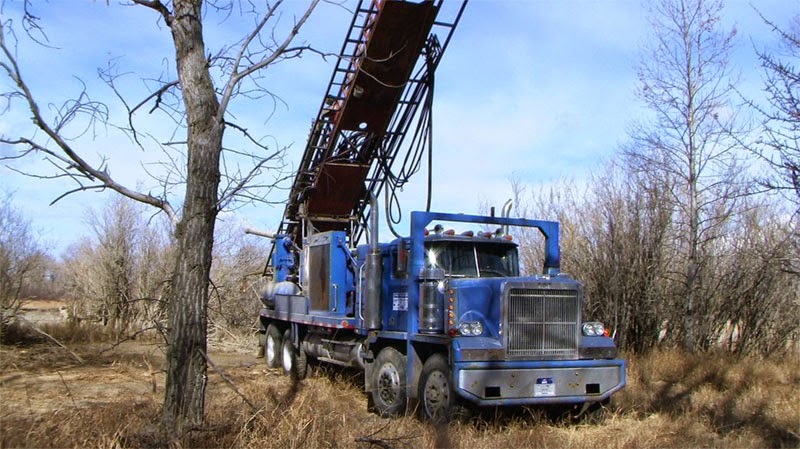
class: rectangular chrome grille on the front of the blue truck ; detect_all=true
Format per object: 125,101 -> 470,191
504,287 -> 581,359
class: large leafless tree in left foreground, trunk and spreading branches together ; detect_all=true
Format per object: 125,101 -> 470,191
0,0 -> 318,435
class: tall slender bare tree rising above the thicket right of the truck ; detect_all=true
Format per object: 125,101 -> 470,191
626,0 -> 746,350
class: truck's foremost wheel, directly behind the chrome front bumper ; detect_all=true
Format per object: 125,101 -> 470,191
418,354 -> 469,424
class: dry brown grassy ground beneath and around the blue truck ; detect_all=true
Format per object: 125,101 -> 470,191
0,322 -> 800,449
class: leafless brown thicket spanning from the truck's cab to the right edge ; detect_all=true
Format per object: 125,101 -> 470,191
515,164 -> 800,355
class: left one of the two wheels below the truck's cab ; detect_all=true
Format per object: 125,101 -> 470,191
371,347 -> 407,417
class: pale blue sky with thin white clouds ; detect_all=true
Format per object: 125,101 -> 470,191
0,0 -> 800,254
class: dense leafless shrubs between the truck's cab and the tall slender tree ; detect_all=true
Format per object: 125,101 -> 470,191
513,162 -> 672,352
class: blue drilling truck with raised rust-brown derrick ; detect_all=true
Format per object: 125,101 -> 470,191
259,0 -> 625,422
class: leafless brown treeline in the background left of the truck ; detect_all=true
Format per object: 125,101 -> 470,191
0,195 -> 268,340
